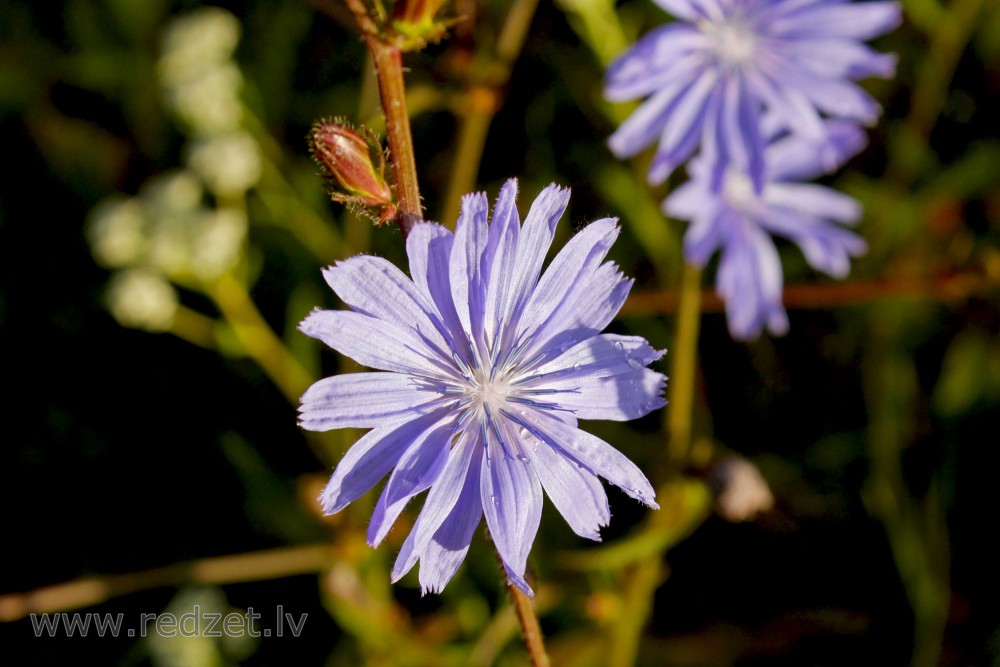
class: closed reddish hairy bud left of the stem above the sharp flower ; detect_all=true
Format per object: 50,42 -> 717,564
309,120 -> 393,207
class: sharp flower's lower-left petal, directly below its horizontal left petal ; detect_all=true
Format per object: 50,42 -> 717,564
319,412 -> 446,514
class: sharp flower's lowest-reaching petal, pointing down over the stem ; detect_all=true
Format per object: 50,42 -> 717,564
479,430 -> 542,596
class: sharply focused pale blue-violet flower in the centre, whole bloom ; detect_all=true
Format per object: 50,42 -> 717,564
300,180 -> 665,594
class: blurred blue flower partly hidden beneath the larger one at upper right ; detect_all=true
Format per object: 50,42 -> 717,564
663,121 -> 867,339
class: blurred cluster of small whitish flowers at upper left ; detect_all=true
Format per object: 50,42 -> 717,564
86,7 -> 262,331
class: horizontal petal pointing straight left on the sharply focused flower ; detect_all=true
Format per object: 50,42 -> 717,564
299,373 -> 440,431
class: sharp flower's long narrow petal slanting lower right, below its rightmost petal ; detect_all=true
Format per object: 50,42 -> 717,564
515,410 -> 659,509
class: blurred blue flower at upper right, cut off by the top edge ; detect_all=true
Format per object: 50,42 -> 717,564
605,0 -> 900,192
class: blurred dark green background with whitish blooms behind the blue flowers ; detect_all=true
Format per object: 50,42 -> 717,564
0,0 -> 1000,667
